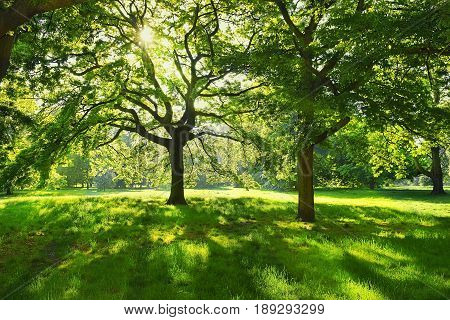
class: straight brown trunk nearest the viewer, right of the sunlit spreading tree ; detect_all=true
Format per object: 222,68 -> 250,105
297,145 -> 315,222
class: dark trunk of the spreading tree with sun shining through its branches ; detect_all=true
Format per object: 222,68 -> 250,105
167,137 -> 187,205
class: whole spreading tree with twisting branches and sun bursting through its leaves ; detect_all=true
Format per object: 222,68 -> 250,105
9,0 -> 260,204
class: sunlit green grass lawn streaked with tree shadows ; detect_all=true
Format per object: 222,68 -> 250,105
0,189 -> 450,299
